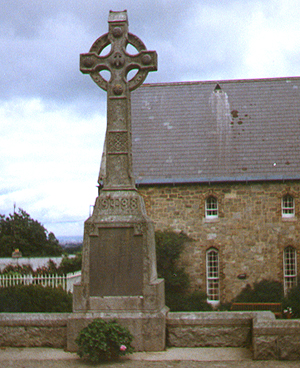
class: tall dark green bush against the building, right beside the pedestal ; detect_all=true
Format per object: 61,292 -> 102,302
155,231 -> 211,311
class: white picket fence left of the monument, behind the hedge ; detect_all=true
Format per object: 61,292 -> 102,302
0,271 -> 81,293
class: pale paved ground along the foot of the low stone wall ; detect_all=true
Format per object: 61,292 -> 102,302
0,348 -> 300,368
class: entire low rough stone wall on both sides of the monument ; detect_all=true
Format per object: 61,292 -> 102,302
0,312 -> 300,360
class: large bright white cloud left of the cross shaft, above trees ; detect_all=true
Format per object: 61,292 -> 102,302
0,99 -> 106,236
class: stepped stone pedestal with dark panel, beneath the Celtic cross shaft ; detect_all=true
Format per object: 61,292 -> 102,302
67,190 -> 167,351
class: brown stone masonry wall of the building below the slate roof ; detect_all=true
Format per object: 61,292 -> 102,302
138,182 -> 300,302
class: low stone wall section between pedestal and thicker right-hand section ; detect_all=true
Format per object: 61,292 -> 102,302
167,312 -> 253,347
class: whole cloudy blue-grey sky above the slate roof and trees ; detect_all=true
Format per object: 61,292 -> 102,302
0,0 -> 300,238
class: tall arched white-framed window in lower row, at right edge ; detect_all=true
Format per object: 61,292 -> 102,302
283,247 -> 297,294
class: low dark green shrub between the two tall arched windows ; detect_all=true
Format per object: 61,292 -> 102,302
234,280 -> 284,303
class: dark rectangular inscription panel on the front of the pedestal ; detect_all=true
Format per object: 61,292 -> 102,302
90,228 -> 143,296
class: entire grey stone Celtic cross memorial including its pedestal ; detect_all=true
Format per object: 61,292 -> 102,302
68,11 -> 167,351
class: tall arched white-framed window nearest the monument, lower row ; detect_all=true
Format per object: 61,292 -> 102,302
206,248 -> 220,302
